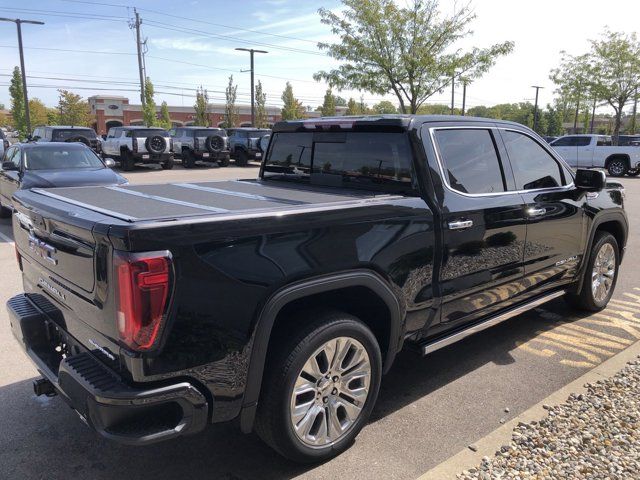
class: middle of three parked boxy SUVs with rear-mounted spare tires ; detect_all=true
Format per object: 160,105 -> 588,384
169,127 -> 229,168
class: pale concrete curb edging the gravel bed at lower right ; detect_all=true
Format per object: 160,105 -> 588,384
418,341 -> 640,480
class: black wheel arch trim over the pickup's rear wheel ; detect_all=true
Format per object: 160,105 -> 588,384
240,270 -> 403,433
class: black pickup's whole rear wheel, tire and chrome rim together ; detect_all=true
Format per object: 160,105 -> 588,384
256,311 -> 382,463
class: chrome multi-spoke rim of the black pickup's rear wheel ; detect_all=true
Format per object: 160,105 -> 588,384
290,337 -> 371,448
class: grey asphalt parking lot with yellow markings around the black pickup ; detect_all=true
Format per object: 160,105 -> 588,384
0,163 -> 640,480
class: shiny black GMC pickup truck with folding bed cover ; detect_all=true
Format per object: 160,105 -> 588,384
7,116 -> 628,462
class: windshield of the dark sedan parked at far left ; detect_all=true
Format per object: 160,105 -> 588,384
24,146 -> 105,170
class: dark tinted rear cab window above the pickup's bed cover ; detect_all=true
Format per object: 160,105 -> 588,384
263,132 -> 413,190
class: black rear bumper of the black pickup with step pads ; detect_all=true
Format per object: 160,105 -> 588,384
7,294 -> 208,445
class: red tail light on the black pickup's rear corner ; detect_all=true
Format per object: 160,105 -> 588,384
115,252 -> 172,350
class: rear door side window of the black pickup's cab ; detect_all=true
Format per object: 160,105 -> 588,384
435,128 -> 506,194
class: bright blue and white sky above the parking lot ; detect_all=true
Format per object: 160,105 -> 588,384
0,0 -> 640,113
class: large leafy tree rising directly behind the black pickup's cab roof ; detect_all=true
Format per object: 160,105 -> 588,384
314,0 -> 513,113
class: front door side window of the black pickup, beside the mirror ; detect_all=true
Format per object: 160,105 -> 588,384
501,130 -> 565,190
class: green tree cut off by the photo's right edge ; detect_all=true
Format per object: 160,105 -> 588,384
591,30 -> 640,143
